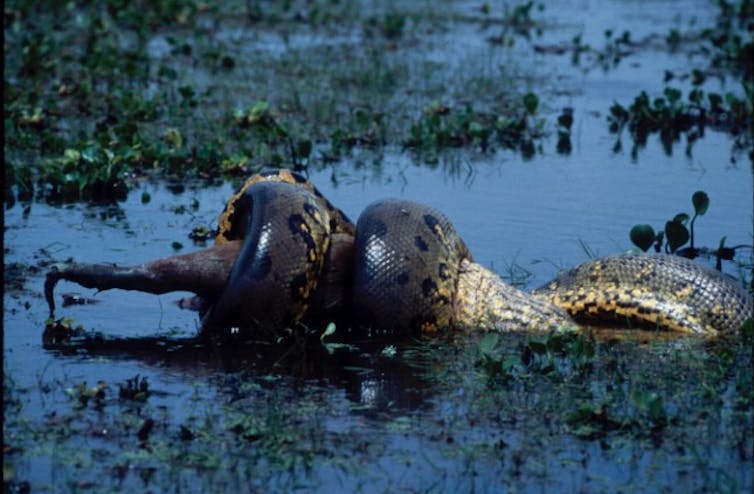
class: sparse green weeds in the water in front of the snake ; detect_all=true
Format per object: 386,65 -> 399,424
4,325 -> 754,491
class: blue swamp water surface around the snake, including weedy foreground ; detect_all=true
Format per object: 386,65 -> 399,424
3,2 -> 754,492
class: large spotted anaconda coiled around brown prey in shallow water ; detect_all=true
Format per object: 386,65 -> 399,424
46,170 -> 754,335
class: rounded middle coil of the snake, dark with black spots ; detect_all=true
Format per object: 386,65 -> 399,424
352,200 -> 471,334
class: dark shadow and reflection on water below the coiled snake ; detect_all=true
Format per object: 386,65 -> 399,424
45,333 -> 433,414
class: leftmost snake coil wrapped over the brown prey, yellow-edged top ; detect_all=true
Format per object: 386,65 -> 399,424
202,170 -> 353,331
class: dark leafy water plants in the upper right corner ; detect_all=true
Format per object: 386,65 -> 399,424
609,0 -> 754,160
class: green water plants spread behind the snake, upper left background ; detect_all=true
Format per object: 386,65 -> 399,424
4,0 -> 542,200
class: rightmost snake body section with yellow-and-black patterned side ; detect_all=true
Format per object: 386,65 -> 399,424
532,254 -> 754,336
